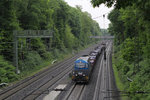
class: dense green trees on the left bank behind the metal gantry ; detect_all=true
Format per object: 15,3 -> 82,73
0,0 -> 100,83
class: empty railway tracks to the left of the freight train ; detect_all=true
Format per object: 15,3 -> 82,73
0,42 -> 101,100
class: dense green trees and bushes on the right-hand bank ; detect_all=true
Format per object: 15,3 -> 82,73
92,0 -> 150,100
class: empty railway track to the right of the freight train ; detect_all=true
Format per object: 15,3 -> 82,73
93,43 -> 120,100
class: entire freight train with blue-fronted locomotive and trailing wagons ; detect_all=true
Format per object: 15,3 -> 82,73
71,43 -> 106,83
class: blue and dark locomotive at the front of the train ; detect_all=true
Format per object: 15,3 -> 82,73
72,56 -> 92,83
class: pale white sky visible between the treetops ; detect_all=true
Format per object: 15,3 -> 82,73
64,0 -> 113,29
